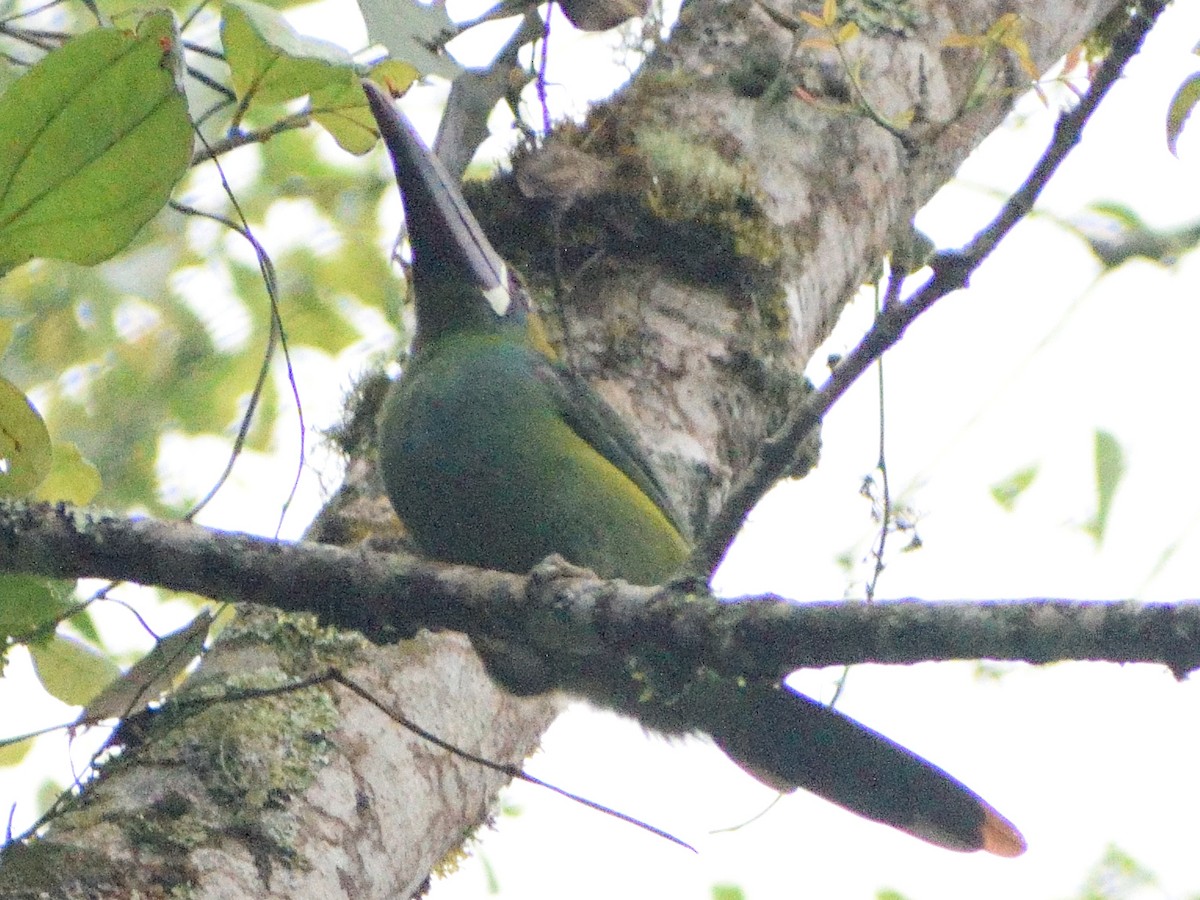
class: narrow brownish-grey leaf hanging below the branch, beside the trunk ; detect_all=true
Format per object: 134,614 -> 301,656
76,610 -> 212,725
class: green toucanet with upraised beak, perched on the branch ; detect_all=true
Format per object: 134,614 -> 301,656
364,80 -> 1026,857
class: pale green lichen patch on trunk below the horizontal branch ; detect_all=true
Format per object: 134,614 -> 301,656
101,608 -> 364,880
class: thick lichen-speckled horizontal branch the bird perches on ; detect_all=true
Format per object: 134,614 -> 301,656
0,503 -> 1200,681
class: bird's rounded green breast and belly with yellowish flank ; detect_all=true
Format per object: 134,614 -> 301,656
379,332 -> 688,584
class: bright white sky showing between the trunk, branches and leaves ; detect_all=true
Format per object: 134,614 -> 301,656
0,4 -> 1200,900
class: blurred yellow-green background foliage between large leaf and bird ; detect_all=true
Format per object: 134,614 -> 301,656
0,88 -> 403,515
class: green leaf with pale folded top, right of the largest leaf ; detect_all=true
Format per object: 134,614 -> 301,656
221,0 -> 361,109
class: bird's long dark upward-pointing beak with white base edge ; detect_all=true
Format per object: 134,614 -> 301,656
362,80 -> 511,316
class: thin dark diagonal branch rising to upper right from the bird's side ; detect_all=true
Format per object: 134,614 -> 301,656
688,0 -> 1165,575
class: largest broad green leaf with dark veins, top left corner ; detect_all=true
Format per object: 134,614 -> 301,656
0,12 -> 192,272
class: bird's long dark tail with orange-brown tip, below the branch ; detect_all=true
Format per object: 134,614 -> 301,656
708,684 -> 1025,857
